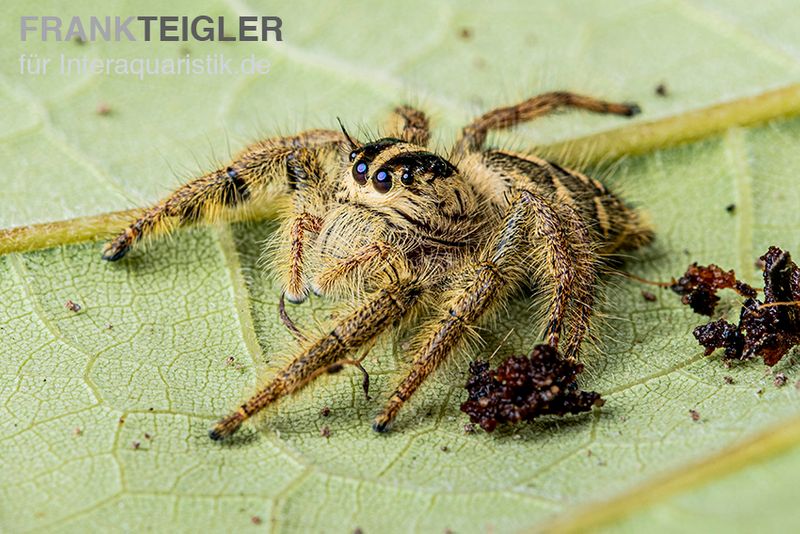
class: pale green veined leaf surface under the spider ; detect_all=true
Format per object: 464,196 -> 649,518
0,0 -> 800,532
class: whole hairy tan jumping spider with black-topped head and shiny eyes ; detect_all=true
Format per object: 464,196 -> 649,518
103,92 -> 653,440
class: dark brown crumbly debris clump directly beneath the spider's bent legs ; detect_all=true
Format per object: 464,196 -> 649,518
461,345 -> 603,432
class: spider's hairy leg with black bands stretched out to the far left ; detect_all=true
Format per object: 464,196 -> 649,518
103,130 -> 346,261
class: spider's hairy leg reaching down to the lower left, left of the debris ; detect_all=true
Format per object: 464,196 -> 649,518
208,280 -> 422,440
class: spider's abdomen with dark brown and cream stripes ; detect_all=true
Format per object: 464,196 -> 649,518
483,151 -> 653,253
